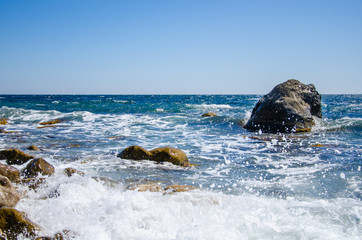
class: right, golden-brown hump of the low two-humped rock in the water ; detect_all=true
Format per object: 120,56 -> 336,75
150,147 -> 190,166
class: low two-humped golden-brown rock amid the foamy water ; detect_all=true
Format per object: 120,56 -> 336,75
118,146 -> 192,167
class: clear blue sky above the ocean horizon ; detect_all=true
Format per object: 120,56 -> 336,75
0,0 -> 362,94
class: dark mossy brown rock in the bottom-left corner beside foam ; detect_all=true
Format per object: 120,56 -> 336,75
0,207 -> 40,240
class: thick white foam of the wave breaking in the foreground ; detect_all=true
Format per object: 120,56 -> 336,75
17,174 -> 362,240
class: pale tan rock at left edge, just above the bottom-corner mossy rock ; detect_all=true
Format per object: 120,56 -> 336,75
0,176 -> 20,207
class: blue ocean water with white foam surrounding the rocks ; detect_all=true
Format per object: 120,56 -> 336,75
0,95 -> 362,240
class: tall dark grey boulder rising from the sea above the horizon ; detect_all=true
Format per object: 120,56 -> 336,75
244,79 -> 322,133
